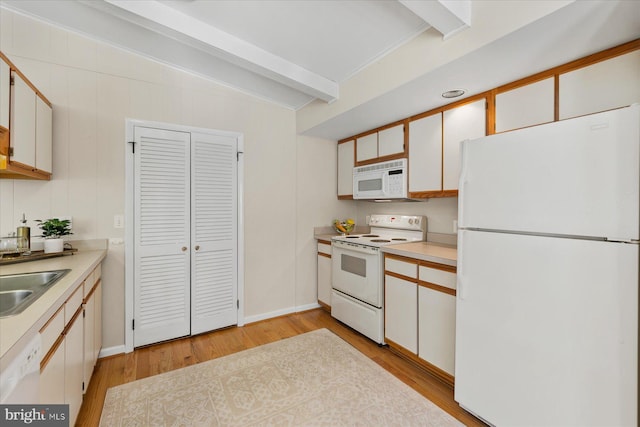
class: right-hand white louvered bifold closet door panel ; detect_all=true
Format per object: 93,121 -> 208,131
191,133 -> 238,334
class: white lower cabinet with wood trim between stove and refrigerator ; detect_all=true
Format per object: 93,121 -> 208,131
385,254 -> 456,383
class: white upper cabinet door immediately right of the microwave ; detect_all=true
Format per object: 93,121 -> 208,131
409,113 -> 442,192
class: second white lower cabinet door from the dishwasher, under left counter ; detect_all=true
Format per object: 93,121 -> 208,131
64,313 -> 84,425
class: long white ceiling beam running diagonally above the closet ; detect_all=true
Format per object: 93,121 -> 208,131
105,0 -> 339,102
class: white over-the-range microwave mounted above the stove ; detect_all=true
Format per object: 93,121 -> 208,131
353,159 -> 407,200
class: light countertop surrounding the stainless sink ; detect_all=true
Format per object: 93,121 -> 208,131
0,249 -> 107,371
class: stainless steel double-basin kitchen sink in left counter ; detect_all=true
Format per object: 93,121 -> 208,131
0,269 -> 71,318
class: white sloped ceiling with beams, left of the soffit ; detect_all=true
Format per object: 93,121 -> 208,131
0,0 -> 470,109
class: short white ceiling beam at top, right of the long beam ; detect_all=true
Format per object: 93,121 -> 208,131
398,0 -> 471,40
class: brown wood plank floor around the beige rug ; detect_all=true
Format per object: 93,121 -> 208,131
76,309 -> 485,427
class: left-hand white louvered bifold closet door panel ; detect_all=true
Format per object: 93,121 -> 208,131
134,126 -> 191,347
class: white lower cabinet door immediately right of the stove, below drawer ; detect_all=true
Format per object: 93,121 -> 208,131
384,275 -> 418,354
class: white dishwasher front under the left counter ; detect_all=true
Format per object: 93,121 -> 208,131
0,334 -> 42,404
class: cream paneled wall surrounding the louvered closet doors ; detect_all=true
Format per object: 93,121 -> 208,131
0,9 -> 318,347
